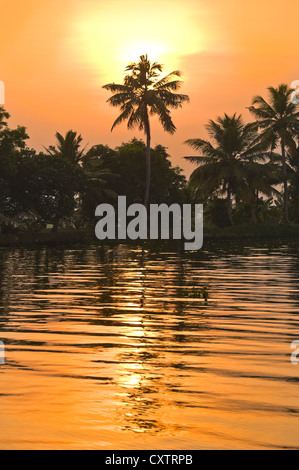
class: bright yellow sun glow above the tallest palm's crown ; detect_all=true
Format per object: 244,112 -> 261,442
69,1 -> 205,81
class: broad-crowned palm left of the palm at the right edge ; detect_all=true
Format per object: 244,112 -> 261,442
185,114 -> 272,225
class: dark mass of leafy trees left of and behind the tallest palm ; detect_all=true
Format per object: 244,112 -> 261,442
0,108 -> 186,233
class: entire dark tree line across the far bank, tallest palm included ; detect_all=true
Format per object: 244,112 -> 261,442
0,56 -> 299,233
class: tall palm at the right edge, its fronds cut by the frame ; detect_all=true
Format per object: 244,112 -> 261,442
248,84 -> 299,223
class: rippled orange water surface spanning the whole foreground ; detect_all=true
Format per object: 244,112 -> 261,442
0,241 -> 299,449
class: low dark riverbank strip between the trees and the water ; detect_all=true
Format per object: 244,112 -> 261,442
0,224 -> 299,247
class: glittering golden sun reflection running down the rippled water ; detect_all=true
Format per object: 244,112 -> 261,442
109,252 -> 190,433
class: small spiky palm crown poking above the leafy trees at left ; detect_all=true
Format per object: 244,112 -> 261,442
46,131 -> 85,164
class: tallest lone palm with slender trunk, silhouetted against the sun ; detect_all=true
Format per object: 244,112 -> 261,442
103,55 -> 189,206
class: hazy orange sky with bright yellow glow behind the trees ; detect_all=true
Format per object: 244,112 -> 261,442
0,0 -> 299,173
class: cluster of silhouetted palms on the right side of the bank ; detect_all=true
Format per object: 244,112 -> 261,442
186,84 -> 299,225
